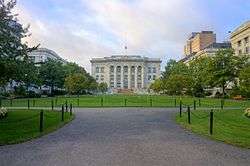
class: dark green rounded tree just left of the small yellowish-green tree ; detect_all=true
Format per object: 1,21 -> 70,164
39,59 -> 65,95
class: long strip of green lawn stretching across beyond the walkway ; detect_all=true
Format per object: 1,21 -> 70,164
0,95 -> 250,108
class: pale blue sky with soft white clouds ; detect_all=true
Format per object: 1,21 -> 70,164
14,0 -> 250,71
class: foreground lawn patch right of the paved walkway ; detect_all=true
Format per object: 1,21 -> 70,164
176,110 -> 250,148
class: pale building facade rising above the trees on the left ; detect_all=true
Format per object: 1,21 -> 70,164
29,48 -> 67,66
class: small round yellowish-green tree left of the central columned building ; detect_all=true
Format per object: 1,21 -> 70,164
64,73 -> 88,94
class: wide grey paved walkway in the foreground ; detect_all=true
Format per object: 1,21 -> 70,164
0,108 -> 250,166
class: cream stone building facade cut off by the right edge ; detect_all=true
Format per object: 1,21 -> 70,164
230,21 -> 250,55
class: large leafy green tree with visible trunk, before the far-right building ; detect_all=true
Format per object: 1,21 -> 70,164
208,49 -> 244,98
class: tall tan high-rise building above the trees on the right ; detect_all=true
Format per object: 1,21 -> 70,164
184,31 -> 216,56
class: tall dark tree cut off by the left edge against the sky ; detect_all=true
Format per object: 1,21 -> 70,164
0,0 -> 37,85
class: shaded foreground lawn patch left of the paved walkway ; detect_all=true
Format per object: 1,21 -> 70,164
0,110 -> 74,145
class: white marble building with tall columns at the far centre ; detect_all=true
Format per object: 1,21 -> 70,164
90,55 -> 161,92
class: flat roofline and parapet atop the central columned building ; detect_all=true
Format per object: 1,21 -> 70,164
90,55 -> 162,63
